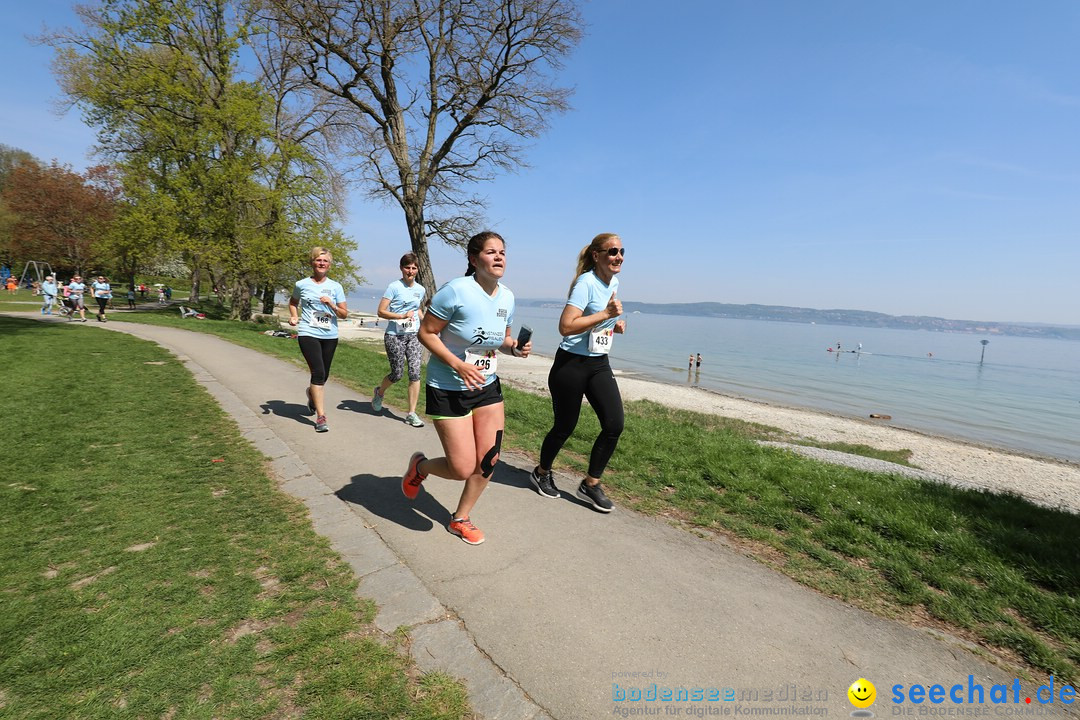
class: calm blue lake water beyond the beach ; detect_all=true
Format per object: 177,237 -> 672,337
507,305 -> 1080,461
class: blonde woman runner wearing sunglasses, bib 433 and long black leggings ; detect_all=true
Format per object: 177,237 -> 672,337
530,232 -> 626,513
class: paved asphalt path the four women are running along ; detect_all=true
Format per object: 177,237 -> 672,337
21,321 -> 1077,720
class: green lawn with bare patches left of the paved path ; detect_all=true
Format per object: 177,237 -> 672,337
0,317 -> 471,719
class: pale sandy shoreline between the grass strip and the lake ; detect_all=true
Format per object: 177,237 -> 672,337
330,316 -> 1080,514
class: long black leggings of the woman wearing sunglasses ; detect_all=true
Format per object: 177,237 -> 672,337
540,348 -> 623,479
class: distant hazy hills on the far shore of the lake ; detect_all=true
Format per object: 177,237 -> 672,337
517,298 -> 1080,340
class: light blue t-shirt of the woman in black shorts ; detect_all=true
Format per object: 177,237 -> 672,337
428,275 -> 514,391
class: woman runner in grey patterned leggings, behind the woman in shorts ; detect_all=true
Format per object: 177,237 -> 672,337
372,253 -> 427,427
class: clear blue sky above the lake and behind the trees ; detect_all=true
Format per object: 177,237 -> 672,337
0,0 -> 1080,324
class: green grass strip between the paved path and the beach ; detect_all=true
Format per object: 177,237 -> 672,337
105,306 -> 1080,681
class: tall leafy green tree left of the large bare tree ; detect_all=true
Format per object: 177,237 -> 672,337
49,0 -> 351,320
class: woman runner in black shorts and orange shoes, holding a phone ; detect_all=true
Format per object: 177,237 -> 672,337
402,231 -> 532,545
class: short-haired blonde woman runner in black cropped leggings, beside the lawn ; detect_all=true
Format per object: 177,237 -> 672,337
288,246 -> 349,433
